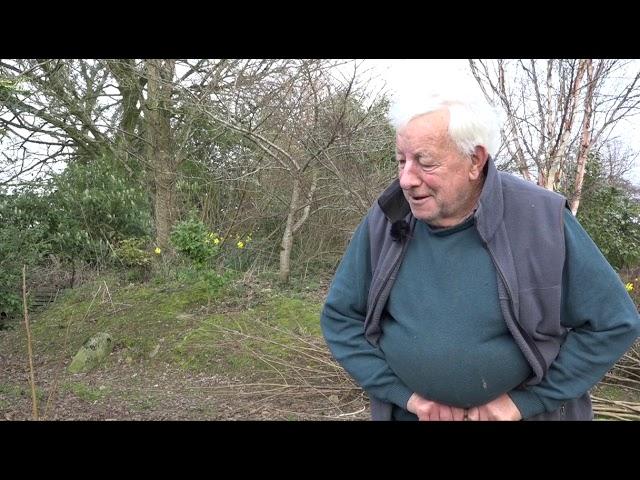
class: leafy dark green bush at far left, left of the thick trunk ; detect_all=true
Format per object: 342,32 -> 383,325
0,151 -> 151,315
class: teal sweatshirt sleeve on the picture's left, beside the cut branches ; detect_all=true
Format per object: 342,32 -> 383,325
320,217 -> 413,408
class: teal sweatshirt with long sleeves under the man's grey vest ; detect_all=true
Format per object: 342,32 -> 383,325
321,211 -> 640,419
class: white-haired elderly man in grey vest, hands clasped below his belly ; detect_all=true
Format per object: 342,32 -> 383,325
321,94 -> 640,420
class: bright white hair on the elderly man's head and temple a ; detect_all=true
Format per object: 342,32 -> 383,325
389,95 -> 500,159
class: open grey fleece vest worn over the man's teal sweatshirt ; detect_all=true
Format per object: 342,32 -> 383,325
364,159 -> 593,420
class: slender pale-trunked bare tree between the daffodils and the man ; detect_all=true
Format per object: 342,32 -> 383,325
185,60 -> 392,282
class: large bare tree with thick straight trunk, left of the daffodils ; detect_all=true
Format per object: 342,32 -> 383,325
0,59 -> 235,247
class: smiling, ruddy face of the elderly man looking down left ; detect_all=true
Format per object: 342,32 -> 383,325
396,110 -> 477,227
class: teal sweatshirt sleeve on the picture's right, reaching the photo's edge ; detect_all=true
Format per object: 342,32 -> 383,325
509,210 -> 640,418
